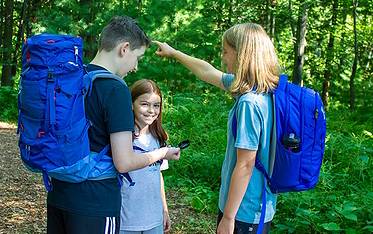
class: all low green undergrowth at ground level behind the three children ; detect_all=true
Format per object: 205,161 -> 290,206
0,86 -> 373,233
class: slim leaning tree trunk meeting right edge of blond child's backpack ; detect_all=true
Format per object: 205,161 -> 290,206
321,0 -> 338,109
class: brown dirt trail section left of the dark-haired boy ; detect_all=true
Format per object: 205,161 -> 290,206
0,126 -> 46,233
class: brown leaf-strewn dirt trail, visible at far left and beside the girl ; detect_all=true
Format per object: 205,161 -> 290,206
0,122 -> 215,234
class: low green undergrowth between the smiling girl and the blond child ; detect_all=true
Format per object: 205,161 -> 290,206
164,89 -> 232,213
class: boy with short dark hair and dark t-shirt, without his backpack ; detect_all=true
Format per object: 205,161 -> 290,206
47,16 -> 180,234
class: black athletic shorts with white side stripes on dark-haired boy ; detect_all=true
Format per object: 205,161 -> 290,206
47,205 -> 120,234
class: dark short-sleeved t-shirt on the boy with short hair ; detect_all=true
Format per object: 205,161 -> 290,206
48,64 -> 134,217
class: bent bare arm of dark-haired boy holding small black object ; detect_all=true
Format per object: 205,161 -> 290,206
110,131 -> 180,173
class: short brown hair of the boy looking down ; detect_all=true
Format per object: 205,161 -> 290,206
98,16 -> 151,51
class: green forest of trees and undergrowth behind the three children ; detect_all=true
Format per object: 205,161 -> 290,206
0,0 -> 373,233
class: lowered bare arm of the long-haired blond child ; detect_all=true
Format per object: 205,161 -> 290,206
217,149 -> 256,234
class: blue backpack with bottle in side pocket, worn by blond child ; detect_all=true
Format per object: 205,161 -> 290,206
232,75 -> 326,233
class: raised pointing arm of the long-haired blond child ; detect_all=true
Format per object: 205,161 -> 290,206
153,41 -> 224,89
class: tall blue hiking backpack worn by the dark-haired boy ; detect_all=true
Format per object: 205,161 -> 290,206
17,34 -> 134,191
